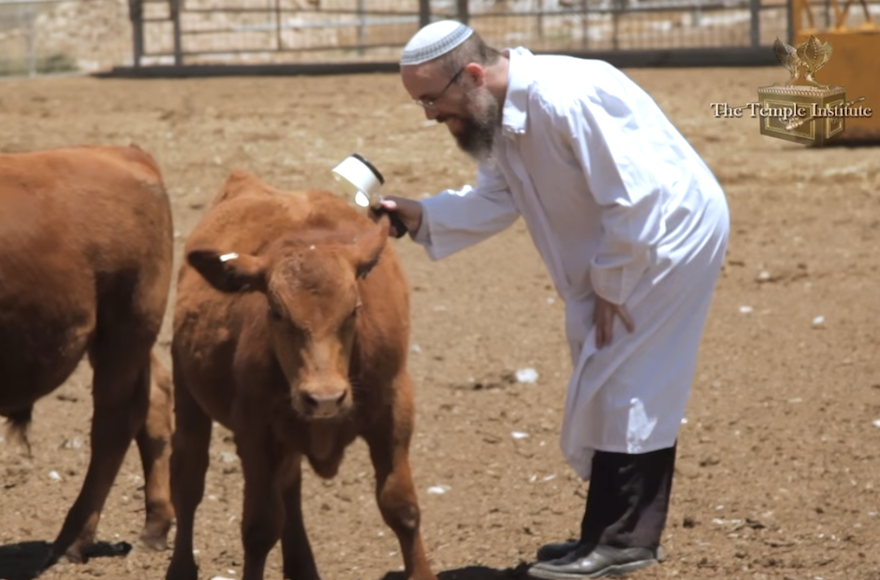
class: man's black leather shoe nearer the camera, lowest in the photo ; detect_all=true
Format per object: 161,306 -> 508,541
529,546 -> 659,580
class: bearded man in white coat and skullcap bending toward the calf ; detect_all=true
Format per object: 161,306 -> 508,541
372,21 -> 729,580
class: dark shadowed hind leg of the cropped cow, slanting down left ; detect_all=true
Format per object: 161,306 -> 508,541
50,340 -> 151,564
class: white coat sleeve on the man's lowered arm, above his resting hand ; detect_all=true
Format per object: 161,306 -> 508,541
557,95 -> 665,304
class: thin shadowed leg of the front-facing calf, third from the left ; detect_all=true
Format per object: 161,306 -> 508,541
281,455 -> 320,580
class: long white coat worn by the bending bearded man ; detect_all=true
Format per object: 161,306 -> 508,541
413,48 -> 729,480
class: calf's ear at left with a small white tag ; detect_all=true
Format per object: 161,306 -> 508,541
186,249 -> 268,292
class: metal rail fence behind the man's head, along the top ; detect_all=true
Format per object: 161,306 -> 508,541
133,0 -> 789,66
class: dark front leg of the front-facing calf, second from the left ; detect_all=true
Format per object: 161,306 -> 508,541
235,428 -> 284,580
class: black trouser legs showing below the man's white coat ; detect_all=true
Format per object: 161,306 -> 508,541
581,445 -> 676,550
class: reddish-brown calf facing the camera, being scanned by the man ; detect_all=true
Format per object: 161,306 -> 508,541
166,172 -> 436,580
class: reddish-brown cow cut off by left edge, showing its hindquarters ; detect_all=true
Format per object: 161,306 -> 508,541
0,147 -> 173,564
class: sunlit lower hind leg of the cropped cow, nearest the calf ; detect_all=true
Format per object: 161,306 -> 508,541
135,360 -> 174,550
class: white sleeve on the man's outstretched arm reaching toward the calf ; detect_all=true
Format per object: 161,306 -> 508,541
412,164 -> 519,260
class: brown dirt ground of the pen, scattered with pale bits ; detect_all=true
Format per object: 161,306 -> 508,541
0,68 -> 880,580
